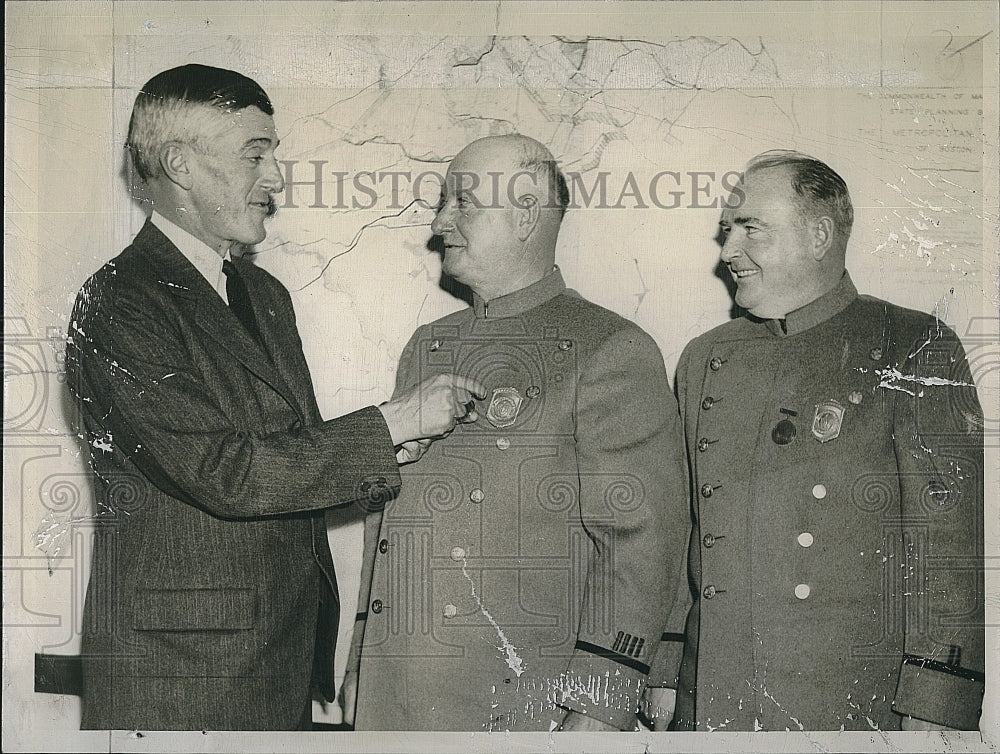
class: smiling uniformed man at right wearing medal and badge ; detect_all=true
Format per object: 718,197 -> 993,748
647,152 -> 984,731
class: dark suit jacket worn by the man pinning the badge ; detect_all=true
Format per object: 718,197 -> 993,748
66,222 -> 399,729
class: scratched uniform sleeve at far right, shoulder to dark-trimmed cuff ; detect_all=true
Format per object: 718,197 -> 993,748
893,322 -> 985,730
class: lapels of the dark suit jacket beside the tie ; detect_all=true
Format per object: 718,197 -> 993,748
133,220 -> 305,422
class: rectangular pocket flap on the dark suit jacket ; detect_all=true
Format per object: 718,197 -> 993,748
132,589 -> 257,631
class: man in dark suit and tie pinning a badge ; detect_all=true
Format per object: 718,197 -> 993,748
67,65 -> 475,729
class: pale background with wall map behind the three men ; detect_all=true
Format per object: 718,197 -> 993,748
3,1 -> 1000,751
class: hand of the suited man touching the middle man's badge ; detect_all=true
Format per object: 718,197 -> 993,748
378,374 -> 486,446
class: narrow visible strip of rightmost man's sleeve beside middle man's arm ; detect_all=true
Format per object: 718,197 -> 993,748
647,347 -> 697,689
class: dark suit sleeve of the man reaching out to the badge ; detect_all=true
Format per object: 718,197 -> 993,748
67,271 -> 400,519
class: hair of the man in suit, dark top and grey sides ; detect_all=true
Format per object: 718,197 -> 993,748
127,63 -> 274,181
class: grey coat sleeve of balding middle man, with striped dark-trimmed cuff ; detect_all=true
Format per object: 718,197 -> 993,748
557,328 -> 688,729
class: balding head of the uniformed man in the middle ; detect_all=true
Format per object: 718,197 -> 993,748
431,134 -> 569,300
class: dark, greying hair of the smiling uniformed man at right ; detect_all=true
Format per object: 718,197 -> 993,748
744,149 -> 854,241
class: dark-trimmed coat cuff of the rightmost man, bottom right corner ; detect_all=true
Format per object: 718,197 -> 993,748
892,655 -> 986,730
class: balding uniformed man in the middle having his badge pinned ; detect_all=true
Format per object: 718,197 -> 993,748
343,135 -> 689,731
